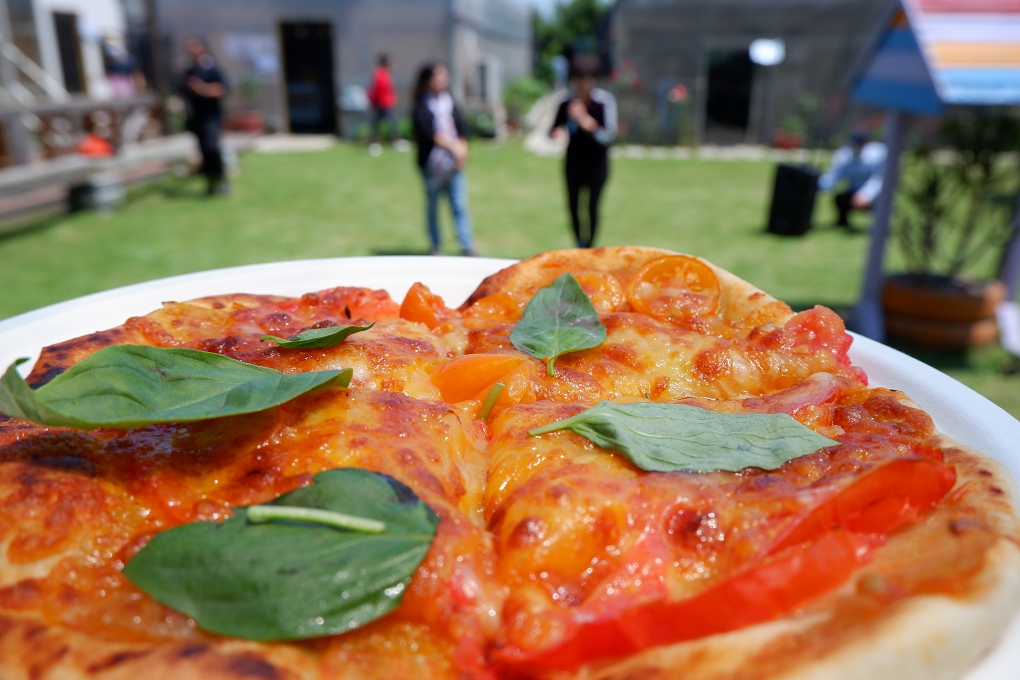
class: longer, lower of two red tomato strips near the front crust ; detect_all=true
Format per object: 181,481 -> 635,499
495,530 -> 869,673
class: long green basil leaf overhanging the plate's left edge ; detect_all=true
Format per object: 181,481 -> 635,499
0,345 -> 354,429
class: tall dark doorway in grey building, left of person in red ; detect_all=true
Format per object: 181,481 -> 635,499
279,21 -> 337,135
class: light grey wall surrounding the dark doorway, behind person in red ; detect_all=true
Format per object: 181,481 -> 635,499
158,0 -> 530,134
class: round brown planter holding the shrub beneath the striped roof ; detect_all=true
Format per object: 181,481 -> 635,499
882,274 -> 1006,349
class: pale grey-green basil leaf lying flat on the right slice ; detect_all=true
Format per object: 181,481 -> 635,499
528,402 -> 839,472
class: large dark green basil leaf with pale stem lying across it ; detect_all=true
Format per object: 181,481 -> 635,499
123,468 -> 439,640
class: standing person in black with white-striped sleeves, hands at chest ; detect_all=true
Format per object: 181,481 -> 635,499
549,55 -> 616,248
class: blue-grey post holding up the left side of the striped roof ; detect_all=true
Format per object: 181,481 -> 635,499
852,111 -> 907,343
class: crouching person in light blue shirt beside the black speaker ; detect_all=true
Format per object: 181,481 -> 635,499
818,130 -> 886,227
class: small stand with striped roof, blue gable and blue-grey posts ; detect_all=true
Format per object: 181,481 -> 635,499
850,0 -> 1020,346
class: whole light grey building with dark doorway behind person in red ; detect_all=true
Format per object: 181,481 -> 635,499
155,0 -> 531,134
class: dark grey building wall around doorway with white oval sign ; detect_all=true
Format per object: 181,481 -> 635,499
613,0 -> 895,143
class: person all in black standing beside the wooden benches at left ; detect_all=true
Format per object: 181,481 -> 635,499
181,38 -> 231,195
